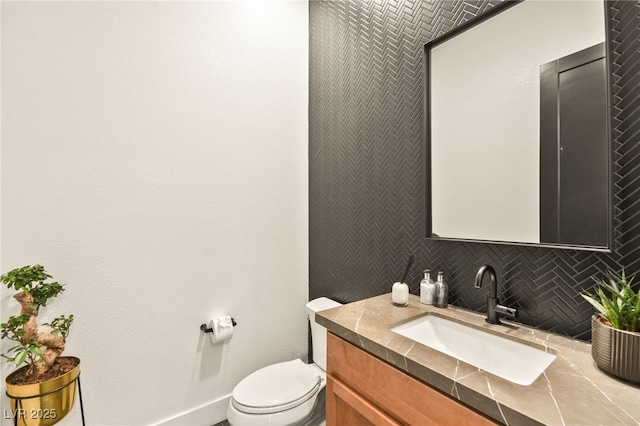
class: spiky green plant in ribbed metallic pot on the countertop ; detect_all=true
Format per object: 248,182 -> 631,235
582,269 -> 640,384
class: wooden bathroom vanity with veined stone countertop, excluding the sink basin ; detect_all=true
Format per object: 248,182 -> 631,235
316,294 -> 640,425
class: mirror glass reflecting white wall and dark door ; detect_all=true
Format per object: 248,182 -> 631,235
426,0 -> 611,249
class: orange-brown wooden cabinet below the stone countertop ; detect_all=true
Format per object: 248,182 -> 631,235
326,333 -> 497,426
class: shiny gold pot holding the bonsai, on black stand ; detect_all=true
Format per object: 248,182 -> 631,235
5,357 -> 80,426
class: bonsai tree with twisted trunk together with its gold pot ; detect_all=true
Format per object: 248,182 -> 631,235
0,265 -> 82,426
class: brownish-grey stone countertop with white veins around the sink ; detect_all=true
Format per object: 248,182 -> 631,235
315,294 -> 640,426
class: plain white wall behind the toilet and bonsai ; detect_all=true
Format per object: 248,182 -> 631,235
0,0 -> 308,425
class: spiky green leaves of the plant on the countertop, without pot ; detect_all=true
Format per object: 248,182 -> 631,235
581,269 -> 640,332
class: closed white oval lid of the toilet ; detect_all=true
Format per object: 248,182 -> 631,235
231,359 -> 322,414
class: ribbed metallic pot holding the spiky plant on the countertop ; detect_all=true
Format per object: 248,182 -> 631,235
591,315 -> 640,384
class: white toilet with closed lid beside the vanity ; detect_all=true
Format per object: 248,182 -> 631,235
227,297 -> 341,426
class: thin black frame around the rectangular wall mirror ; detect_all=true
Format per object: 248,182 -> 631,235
423,0 -> 614,253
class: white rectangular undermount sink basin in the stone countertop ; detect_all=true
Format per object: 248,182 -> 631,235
391,315 -> 556,386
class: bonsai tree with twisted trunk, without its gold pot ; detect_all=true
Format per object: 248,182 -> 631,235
0,265 -> 73,376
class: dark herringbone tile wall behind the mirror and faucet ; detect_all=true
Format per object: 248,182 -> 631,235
309,0 -> 640,340
